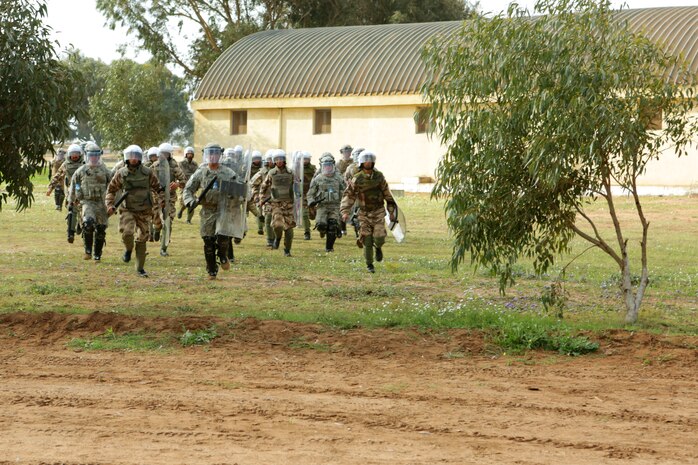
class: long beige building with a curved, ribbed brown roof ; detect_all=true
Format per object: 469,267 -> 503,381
192,7 -> 698,188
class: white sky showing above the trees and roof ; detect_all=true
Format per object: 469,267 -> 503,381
46,0 -> 698,63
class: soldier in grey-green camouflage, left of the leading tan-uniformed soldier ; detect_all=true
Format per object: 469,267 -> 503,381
68,142 -> 112,262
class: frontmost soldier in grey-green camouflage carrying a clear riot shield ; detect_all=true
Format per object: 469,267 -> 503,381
184,144 -> 243,279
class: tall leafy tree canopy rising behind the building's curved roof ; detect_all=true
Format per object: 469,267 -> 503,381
97,0 -> 474,84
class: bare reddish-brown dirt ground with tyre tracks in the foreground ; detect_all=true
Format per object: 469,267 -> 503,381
0,313 -> 698,465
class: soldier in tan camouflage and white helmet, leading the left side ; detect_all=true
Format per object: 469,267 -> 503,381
105,145 -> 162,277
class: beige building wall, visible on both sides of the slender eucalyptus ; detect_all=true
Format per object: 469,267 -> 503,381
192,100 -> 698,189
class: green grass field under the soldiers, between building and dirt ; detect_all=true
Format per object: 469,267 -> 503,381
0,170 -> 698,344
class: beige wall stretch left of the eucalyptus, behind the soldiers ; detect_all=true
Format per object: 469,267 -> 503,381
194,97 -> 442,182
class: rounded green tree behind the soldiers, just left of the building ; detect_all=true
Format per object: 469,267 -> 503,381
90,59 -> 193,149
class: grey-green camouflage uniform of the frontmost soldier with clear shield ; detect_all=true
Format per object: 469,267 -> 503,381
183,165 -> 244,278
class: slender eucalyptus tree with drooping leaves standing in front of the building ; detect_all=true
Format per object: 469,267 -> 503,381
423,0 -> 696,323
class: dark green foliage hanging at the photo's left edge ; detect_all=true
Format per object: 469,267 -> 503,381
0,0 -> 84,210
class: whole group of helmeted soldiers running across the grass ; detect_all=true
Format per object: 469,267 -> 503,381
46,143 -> 397,279
